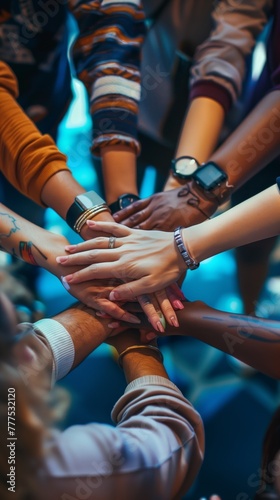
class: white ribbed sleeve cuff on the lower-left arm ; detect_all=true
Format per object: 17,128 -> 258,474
34,319 -> 75,380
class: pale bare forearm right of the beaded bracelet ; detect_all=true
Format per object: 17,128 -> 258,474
183,185 -> 280,262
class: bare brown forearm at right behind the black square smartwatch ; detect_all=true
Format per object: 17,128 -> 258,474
210,90 -> 280,191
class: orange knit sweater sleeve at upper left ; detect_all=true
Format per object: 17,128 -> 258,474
0,61 -> 69,205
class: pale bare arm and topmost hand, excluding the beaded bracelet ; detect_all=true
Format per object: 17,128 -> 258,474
54,180 -> 280,300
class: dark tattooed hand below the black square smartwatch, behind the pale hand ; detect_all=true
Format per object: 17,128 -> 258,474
113,181 -> 218,231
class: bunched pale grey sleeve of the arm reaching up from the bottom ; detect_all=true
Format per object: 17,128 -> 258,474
41,377 -> 204,500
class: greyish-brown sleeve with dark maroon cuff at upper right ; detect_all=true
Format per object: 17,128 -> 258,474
191,0 -> 273,108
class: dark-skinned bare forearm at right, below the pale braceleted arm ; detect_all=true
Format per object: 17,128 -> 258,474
166,301 -> 280,378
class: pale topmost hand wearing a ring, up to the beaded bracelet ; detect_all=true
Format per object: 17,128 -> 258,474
57,221 -> 186,300
